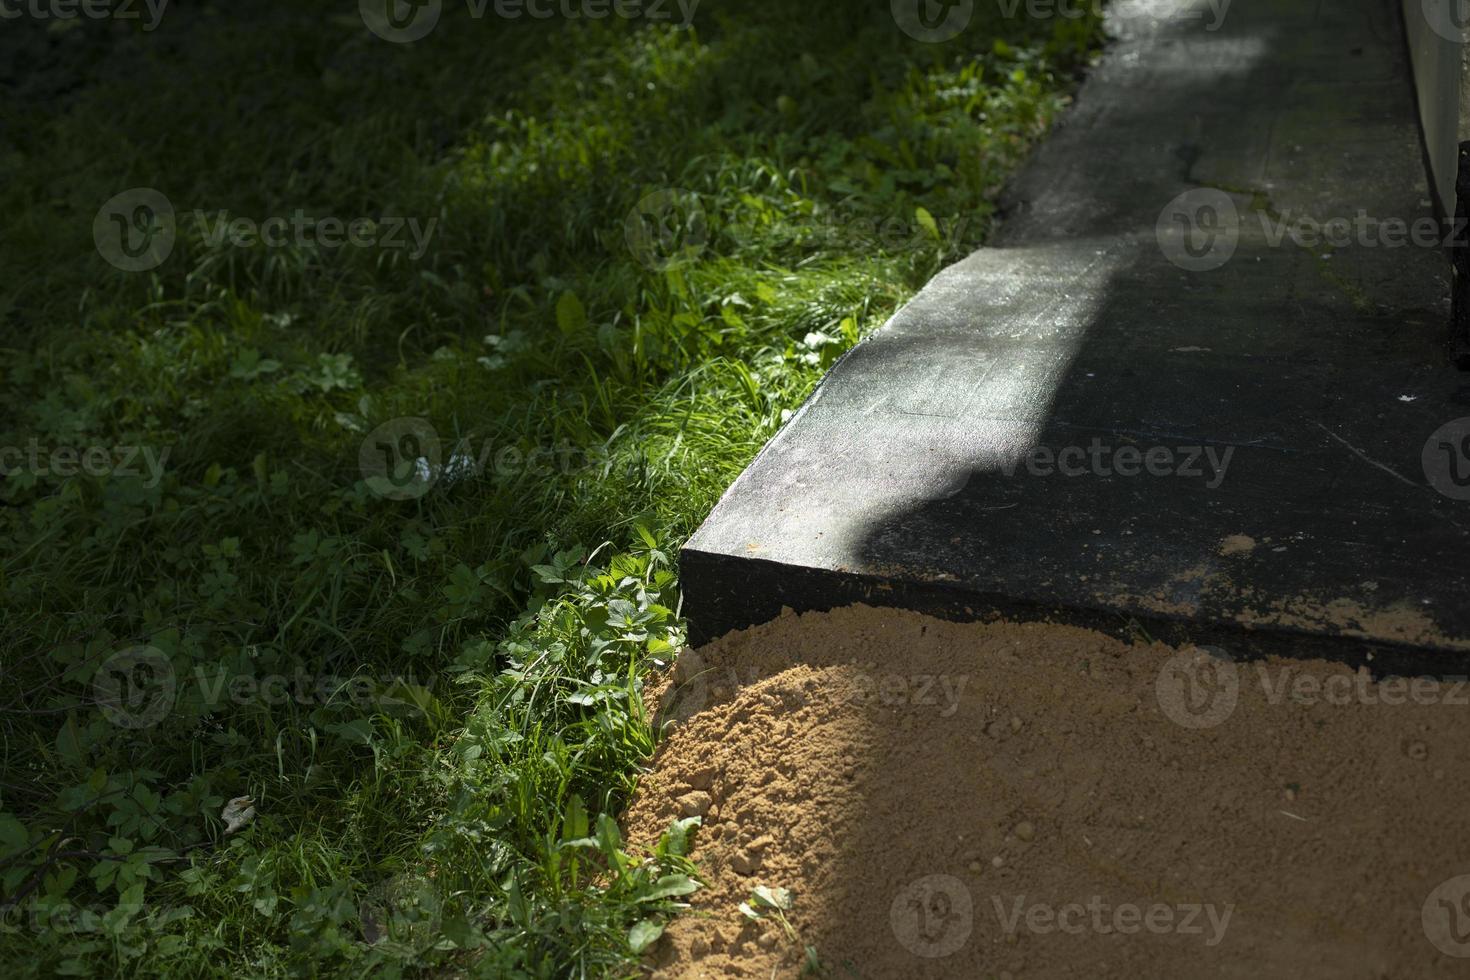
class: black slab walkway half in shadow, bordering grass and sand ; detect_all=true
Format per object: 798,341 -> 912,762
681,0 -> 1470,663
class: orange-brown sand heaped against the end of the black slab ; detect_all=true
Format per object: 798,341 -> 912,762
626,607 -> 1470,979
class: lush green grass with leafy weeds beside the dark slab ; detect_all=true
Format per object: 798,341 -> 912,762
0,0 -> 1098,977
